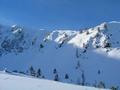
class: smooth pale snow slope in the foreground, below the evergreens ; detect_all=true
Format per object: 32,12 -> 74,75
0,72 -> 108,90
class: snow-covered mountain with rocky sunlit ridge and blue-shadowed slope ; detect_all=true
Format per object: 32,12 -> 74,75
0,21 -> 120,88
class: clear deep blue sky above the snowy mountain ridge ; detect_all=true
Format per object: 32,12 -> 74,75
0,0 -> 120,30
